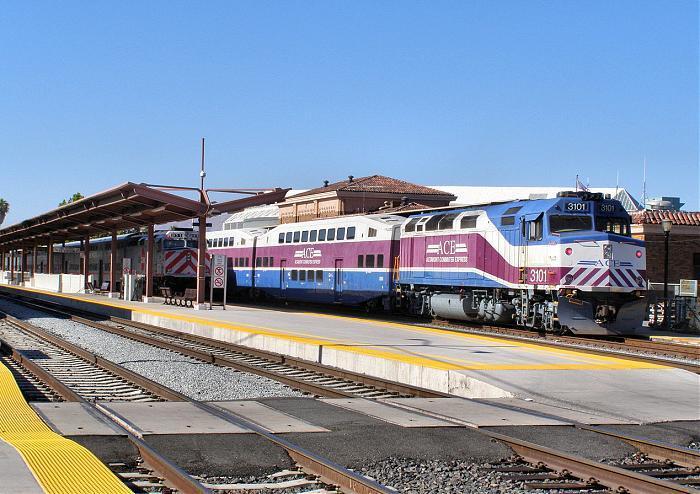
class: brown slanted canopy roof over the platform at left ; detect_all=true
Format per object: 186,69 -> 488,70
0,182 -> 289,249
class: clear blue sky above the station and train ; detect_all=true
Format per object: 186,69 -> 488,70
0,0 -> 700,225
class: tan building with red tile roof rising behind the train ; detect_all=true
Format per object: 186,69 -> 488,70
279,175 -> 456,223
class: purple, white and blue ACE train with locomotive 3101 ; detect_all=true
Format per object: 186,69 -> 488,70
207,192 -> 646,335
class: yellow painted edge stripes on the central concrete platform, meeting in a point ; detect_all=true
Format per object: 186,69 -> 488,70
0,285 -> 672,370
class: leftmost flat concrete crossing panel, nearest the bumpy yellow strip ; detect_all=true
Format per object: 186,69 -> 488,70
30,402 -> 123,436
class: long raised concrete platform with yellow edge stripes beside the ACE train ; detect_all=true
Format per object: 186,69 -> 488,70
0,286 -> 700,422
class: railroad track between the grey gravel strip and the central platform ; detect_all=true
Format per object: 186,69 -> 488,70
0,297 -> 449,399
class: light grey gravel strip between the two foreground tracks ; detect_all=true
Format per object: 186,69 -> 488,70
0,300 -> 304,401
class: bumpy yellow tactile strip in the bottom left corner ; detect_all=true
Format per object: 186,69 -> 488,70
0,363 -> 131,494
